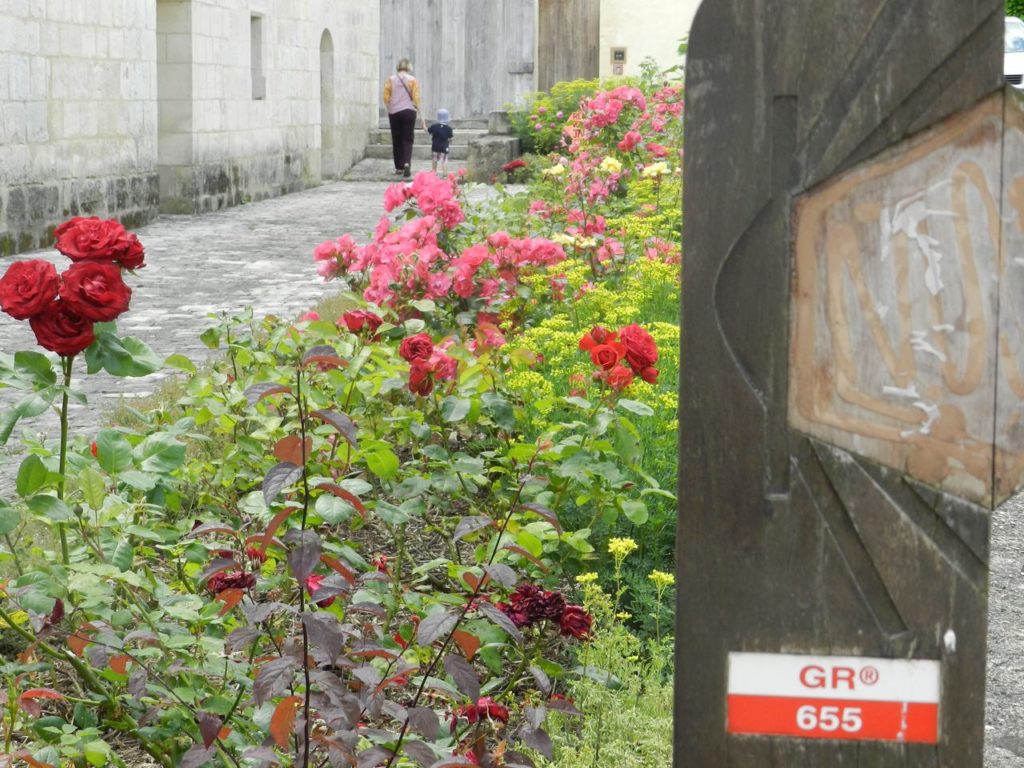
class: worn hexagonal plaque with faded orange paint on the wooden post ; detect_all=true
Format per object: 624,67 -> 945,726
790,94 -> 1024,506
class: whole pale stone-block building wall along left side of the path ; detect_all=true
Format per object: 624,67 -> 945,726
0,0 -> 379,256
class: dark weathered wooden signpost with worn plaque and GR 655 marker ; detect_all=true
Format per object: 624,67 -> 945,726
675,0 -> 1007,768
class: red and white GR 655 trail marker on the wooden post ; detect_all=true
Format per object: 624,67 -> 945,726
726,653 -> 941,744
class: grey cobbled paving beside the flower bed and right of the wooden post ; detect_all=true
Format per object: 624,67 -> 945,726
0,161 -> 1024,768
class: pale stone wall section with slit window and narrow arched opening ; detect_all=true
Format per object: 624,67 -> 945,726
158,0 -> 379,212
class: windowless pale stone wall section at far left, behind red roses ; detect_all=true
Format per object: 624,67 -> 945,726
0,0 -> 158,256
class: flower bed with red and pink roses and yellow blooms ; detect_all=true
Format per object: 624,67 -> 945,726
0,72 -> 682,768
